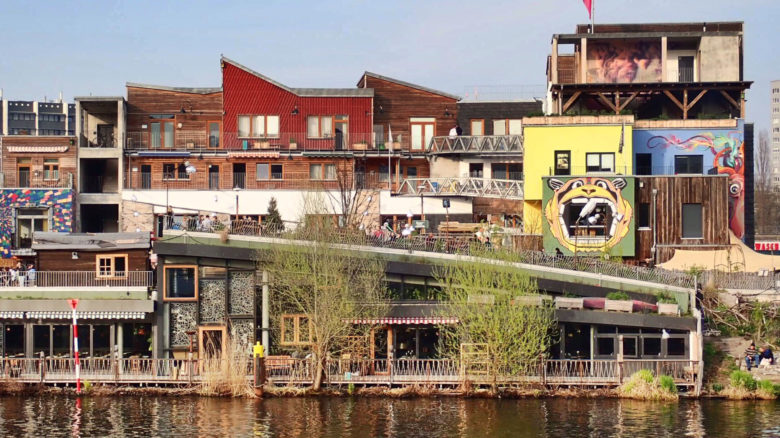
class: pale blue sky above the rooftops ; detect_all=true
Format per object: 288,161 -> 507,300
0,0 -> 780,128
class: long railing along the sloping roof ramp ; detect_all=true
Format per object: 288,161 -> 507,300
164,216 -> 694,289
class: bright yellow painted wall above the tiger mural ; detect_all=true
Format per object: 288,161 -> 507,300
523,124 -> 634,201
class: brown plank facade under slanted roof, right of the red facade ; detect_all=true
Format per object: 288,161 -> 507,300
358,75 -> 458,149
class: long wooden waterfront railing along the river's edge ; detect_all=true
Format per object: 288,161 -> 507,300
0,357 -> 699,387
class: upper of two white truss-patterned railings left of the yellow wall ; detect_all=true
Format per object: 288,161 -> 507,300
427,135 -> 523,155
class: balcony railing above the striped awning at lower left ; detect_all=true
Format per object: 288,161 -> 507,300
0,271 -> 154,288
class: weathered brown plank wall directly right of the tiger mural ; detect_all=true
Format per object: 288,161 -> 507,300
634,176 -> 730,263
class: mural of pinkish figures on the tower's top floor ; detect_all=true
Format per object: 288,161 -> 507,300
587,40 -> 662,83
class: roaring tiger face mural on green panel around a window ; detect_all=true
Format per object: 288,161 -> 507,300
542,176 -> 635,257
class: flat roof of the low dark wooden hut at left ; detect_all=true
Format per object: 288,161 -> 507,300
32,232 -> 151,251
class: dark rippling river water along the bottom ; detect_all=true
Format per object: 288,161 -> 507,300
0,395 -> 780,438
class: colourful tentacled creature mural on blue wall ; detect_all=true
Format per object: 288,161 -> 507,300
634,125 -> 746,239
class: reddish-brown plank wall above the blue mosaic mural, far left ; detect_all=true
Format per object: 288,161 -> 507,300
0,136 -> 78,189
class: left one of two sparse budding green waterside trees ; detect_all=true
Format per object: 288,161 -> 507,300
266,227 -> 387,390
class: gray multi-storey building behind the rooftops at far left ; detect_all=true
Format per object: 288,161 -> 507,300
0,93 -> 76,136
